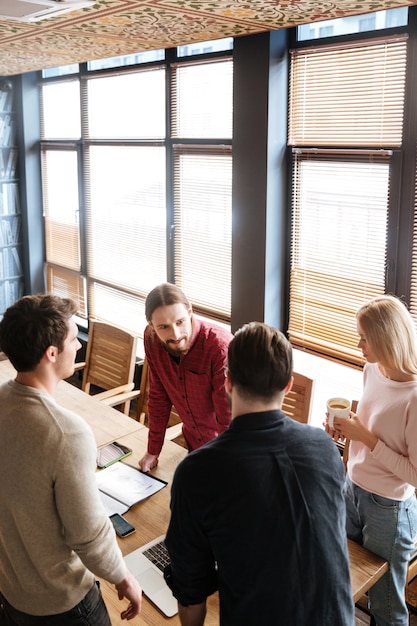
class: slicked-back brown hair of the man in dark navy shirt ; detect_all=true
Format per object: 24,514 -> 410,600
228,322 -> 293,398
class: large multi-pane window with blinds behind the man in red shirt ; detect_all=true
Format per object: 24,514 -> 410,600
41,46 -> 233,333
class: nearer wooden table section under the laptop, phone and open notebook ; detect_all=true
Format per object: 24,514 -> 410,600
96,428 -> 388,626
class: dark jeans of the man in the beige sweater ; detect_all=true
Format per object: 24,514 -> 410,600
0,582 -> 111,626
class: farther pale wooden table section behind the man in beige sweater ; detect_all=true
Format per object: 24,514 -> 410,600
0,360 -> 141,446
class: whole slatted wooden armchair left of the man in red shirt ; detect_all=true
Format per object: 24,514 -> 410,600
75,321 -> 139,415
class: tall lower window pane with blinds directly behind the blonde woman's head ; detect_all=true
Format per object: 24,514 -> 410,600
289,159 -> 389,362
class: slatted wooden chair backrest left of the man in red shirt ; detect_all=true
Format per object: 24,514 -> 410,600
82,322 -> 138,393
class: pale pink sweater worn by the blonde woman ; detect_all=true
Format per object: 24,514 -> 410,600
348,363 -> 417,500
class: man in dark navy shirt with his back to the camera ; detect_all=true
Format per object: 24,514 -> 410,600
165,322 -> 355,626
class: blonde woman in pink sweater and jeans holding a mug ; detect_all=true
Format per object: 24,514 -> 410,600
334,296 -> 417,626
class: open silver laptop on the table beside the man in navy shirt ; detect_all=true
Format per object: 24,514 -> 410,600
124,535 -> 178,617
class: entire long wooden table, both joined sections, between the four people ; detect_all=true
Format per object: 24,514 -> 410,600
0,360 -> 388,626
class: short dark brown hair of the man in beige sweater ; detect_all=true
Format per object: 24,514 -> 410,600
0,295 -> 77,372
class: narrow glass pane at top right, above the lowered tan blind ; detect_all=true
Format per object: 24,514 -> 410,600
297,7 -> 408,41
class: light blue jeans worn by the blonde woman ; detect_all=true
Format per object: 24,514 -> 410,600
345,477 -> 417,626
